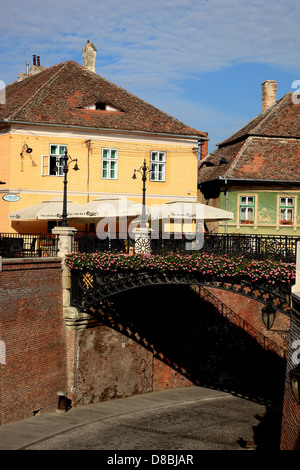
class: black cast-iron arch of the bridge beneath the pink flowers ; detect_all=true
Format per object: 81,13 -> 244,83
71,269 -> 291,316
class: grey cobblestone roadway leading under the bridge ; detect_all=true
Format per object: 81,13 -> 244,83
26,394 -> 266,451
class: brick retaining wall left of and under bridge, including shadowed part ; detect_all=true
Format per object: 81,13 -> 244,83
0,258 -> 292,440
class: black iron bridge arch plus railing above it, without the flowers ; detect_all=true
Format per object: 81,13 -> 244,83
67,234 -> 299,316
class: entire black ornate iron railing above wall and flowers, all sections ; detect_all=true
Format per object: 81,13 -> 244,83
0,232 -> 300,262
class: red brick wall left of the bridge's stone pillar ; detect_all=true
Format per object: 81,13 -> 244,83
0,258 -> 67,424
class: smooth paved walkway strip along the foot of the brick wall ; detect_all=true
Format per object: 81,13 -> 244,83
0,386 -> 228,450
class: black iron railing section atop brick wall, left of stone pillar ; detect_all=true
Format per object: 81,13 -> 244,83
0,233 -> 58,258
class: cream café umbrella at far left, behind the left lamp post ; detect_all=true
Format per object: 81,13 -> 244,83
8,198 -> 82,220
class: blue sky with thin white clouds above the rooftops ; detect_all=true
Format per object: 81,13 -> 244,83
0,0 -> 300,151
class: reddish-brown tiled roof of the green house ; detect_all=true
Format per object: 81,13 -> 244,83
198,93 -> 300,183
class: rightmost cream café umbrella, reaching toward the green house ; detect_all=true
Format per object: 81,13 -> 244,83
151,201 -> 234,222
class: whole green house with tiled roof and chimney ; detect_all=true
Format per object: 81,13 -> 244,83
198,81 -> 300,236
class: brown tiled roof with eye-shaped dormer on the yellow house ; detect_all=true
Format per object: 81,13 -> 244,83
0,61 -> 206,138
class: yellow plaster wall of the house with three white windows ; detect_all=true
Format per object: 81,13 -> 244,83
0,133 -> 197,232
